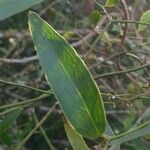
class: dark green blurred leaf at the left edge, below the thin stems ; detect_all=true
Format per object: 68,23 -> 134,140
0,108 -> 21,136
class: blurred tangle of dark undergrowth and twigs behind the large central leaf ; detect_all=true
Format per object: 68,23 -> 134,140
0,0 -> 150,150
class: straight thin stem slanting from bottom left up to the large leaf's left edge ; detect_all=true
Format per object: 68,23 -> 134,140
16,103 -> 57,150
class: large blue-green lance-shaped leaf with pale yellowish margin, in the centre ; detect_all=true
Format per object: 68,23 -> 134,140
29,12 -> 106,139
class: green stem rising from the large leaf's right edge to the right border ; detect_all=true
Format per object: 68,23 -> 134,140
94,63 -> 150,80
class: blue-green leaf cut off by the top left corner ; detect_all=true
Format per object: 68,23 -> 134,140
0,0 -> 43,20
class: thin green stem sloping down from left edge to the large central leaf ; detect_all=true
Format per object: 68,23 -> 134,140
0,79 -> 52,94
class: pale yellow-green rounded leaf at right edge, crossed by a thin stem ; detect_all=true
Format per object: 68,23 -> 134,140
138,10 -> 150,31
